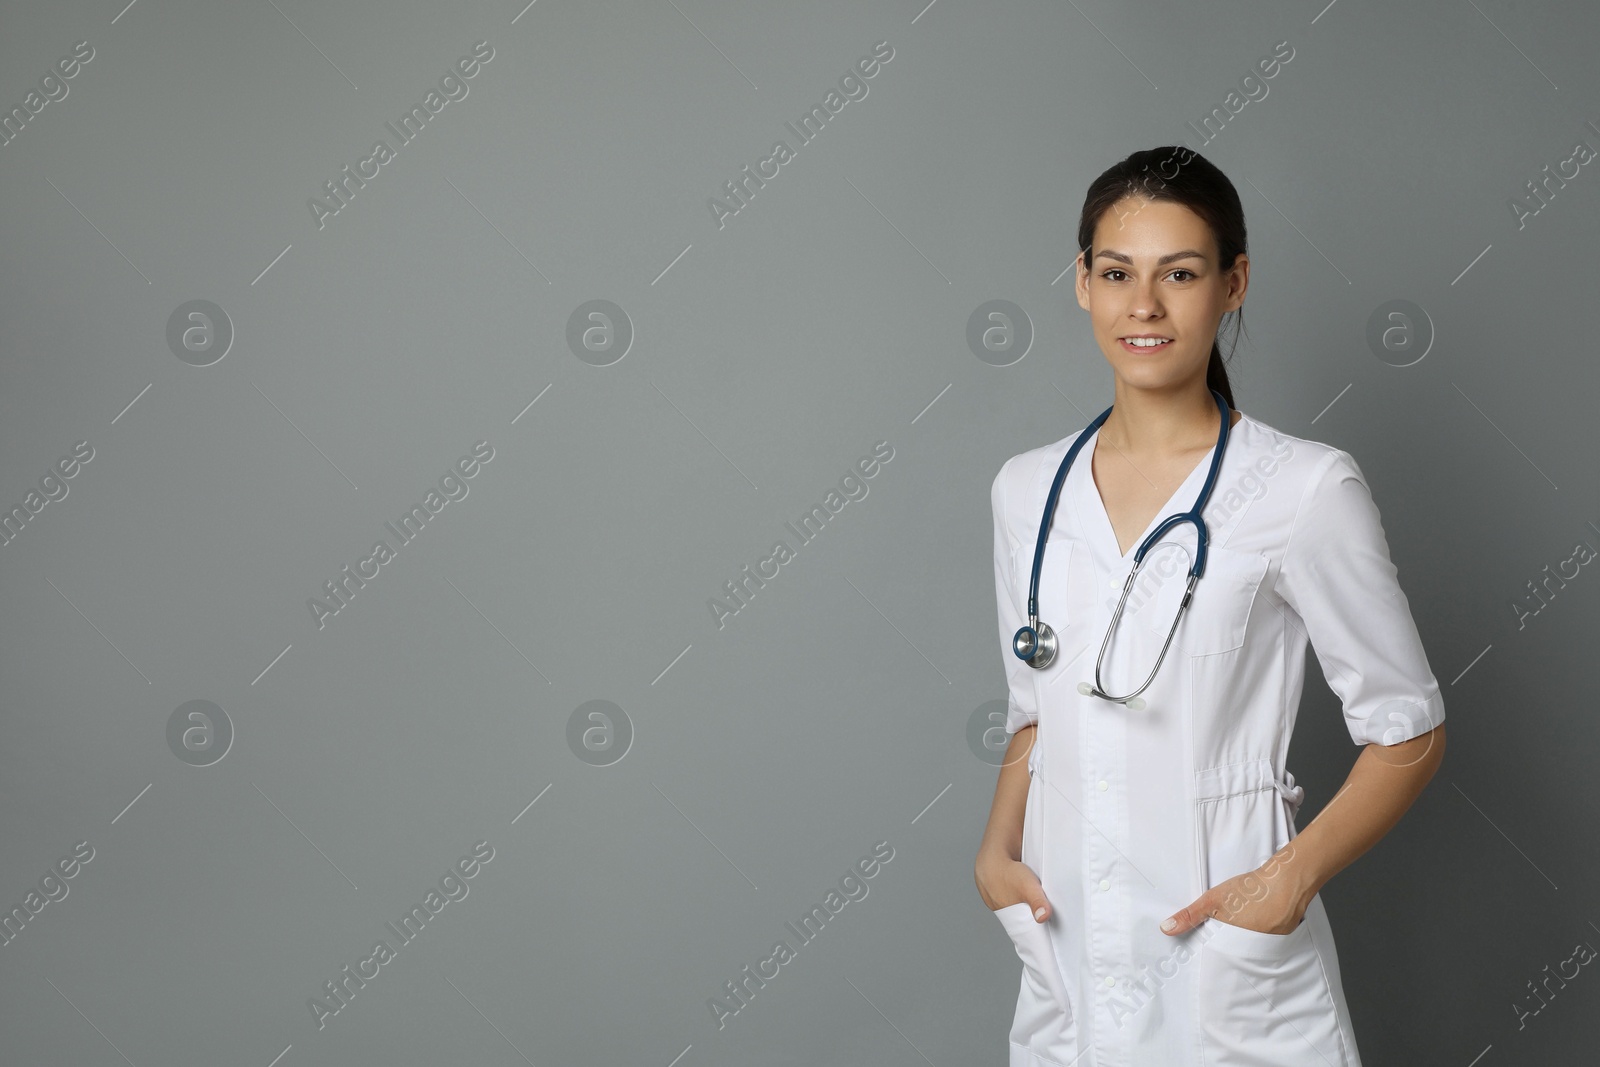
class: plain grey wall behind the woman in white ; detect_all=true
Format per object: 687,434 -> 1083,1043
0,0 -> 1600,1067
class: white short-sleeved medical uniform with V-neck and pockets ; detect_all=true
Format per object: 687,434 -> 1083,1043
990,414 -> 1445,1067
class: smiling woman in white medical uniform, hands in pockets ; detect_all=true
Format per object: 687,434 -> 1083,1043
974,147 -> 1445,1067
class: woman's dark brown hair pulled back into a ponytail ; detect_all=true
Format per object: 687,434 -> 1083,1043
1078,144 -> 1246,408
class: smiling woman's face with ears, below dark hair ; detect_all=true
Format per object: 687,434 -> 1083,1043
1077,197 -> 1250,392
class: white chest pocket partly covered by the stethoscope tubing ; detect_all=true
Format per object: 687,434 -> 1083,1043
1112,543 -> 1267,656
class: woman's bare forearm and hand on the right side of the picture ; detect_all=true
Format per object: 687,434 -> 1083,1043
1163,723 -> 1445,934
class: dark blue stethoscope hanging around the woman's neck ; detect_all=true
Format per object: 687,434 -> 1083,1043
1011,389 -> 1232,712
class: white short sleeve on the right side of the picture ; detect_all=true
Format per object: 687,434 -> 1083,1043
1277,450 -> 1445,745
